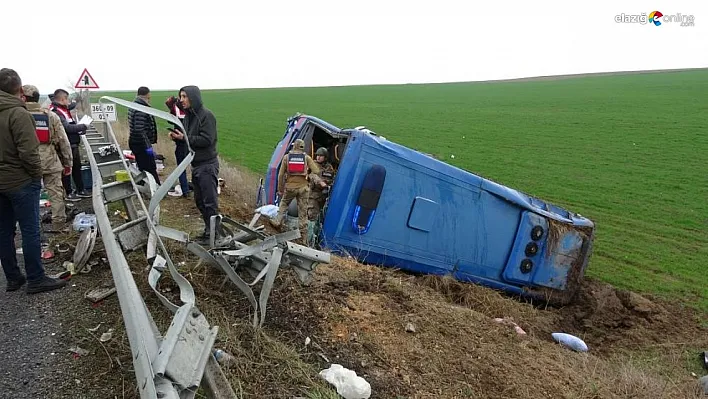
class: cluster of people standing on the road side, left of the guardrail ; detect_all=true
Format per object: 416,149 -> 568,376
0,68 -> 88,294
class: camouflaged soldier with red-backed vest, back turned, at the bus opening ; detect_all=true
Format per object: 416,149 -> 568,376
270,139 -> 320,239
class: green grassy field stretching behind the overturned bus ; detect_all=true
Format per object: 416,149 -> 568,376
97,70 -> 708,310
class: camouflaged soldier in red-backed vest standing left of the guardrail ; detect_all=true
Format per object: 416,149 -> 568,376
22,85 -> 73,230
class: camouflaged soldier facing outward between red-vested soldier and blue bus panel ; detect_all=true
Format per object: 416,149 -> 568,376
307,147 -> 336,246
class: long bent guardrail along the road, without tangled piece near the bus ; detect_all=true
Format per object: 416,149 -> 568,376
82,96 -> 236,399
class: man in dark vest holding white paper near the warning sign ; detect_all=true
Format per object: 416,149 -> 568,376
49,89 -> 91,201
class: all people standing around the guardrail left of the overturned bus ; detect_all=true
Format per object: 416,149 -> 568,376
0,68 -> 224,294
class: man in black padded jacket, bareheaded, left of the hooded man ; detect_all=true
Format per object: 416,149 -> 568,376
128,86 -> 160,185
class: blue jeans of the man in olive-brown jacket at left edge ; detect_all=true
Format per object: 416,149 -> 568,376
0,180 -> 44,281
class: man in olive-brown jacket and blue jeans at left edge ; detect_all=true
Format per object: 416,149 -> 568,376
0,68 -> 66,294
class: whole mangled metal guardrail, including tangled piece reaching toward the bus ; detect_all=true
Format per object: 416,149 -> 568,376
82,96 -> 330,398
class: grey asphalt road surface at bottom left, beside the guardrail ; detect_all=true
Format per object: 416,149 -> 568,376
0,223 -> 126,399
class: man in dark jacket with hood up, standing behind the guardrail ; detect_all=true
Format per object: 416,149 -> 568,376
170,86 -> 219,242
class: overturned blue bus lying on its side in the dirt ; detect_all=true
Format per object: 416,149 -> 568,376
264,114 -> 595,304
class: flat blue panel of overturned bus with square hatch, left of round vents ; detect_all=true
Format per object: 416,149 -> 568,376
323,140 -> 520,280
